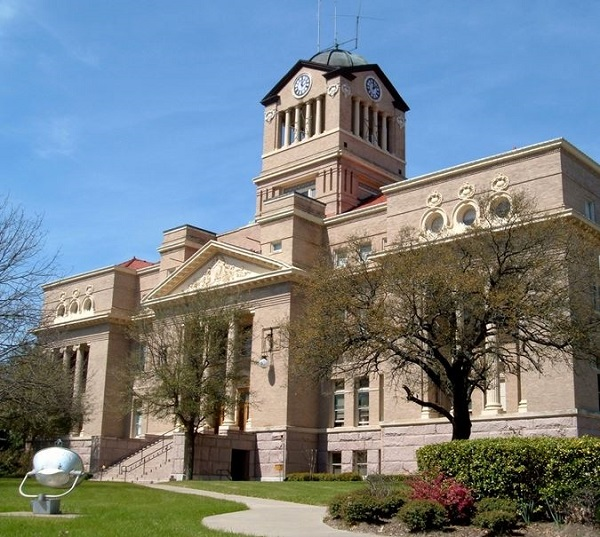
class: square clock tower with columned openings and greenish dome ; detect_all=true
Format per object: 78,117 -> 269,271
254,48 -> 408,219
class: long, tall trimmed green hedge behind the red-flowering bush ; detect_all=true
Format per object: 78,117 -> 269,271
417,437 -> 600,510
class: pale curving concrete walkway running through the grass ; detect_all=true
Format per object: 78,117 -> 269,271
147,484 -> 373,537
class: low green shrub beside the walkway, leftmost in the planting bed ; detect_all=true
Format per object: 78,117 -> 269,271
329,489 -> 406,524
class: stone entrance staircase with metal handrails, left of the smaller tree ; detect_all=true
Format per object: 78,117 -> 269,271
96,436 -> 173,483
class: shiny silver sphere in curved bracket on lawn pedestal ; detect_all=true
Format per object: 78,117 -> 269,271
19,446 -> 85,515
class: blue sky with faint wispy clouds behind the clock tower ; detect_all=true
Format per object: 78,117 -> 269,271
0,0 -> 600,275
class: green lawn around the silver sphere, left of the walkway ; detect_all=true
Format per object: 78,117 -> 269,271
0,479 -> 244,537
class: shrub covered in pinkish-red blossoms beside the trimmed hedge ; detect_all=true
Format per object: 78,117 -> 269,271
410,474 -> 475,524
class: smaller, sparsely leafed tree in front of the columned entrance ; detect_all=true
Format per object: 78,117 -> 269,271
131,290 -> 249,479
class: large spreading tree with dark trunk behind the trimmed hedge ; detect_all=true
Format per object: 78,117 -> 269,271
290,194 -> 600,439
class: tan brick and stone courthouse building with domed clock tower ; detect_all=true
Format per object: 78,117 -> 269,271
44,49 -> 600,480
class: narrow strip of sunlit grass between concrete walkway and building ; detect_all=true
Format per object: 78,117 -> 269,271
169,481 -> 365,505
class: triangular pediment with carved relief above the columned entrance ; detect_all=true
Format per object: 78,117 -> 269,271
143,241 -> 295,303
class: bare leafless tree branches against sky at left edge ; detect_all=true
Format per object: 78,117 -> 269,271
0,198 -> 55,361
